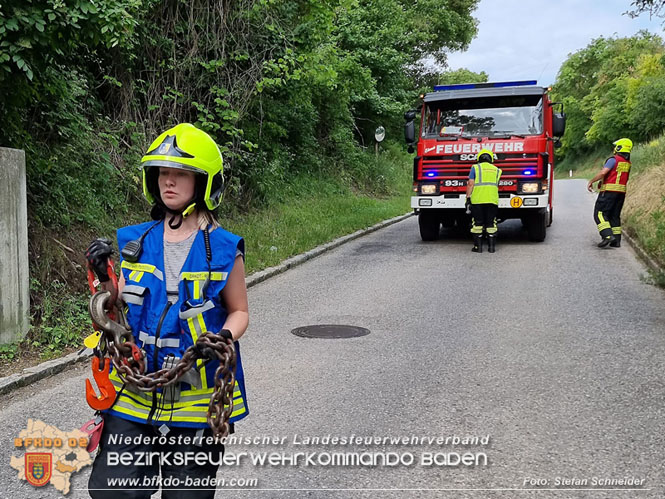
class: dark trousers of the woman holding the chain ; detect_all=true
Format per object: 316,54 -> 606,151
88,414 -> 224,499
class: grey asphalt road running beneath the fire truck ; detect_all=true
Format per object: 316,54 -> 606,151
0,180 -> 665,499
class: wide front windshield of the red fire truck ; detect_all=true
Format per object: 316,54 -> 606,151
421,95 -> 543,139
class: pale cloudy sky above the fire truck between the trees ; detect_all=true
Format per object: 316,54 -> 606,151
448,0 -> 663,86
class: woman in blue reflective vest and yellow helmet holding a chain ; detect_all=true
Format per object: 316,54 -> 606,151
86,123 -> 249,499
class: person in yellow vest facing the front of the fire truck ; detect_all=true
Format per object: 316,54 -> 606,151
466,149 -> 501,253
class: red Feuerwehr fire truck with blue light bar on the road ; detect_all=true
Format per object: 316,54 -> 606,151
404,81 -> 566,241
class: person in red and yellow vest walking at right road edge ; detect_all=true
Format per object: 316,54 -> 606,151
587,138 -> 633,248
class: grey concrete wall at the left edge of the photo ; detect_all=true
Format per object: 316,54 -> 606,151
0,147 -> 30,344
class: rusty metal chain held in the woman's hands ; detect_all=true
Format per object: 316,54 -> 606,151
89,291 -> 236,438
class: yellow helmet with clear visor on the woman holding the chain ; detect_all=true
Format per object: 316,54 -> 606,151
141,123 -> 224,216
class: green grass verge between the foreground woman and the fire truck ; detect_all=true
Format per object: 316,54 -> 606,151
219,141 -> 413,274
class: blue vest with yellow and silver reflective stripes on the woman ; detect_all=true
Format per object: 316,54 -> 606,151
108,222 -> 249,428
